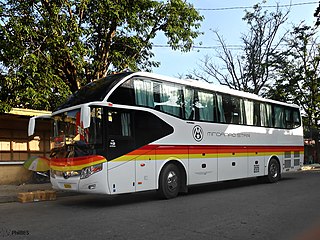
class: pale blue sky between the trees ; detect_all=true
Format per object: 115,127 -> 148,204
153,0 -> 319,77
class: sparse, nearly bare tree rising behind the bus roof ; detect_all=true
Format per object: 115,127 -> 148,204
194,4 -> 289,95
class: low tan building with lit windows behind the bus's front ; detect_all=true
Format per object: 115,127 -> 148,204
0,108 -> 50,185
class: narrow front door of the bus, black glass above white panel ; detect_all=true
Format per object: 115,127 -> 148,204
105,108 -> 135,194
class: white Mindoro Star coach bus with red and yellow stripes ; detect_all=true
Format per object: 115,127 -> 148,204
29,72 -> 304,199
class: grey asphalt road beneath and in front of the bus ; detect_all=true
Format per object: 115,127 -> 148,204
0,171 -> 320,240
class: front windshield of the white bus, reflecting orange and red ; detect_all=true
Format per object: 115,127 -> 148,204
51,108 -> 102,157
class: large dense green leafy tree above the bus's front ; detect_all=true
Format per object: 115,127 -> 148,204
0,0 -> 203,111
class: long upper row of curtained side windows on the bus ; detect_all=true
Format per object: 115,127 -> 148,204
108,77 -> 301,128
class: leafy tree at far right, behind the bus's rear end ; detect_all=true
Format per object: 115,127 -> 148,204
269,24 -> 320,129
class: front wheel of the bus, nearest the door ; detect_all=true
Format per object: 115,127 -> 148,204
158,163 -> 181,199
